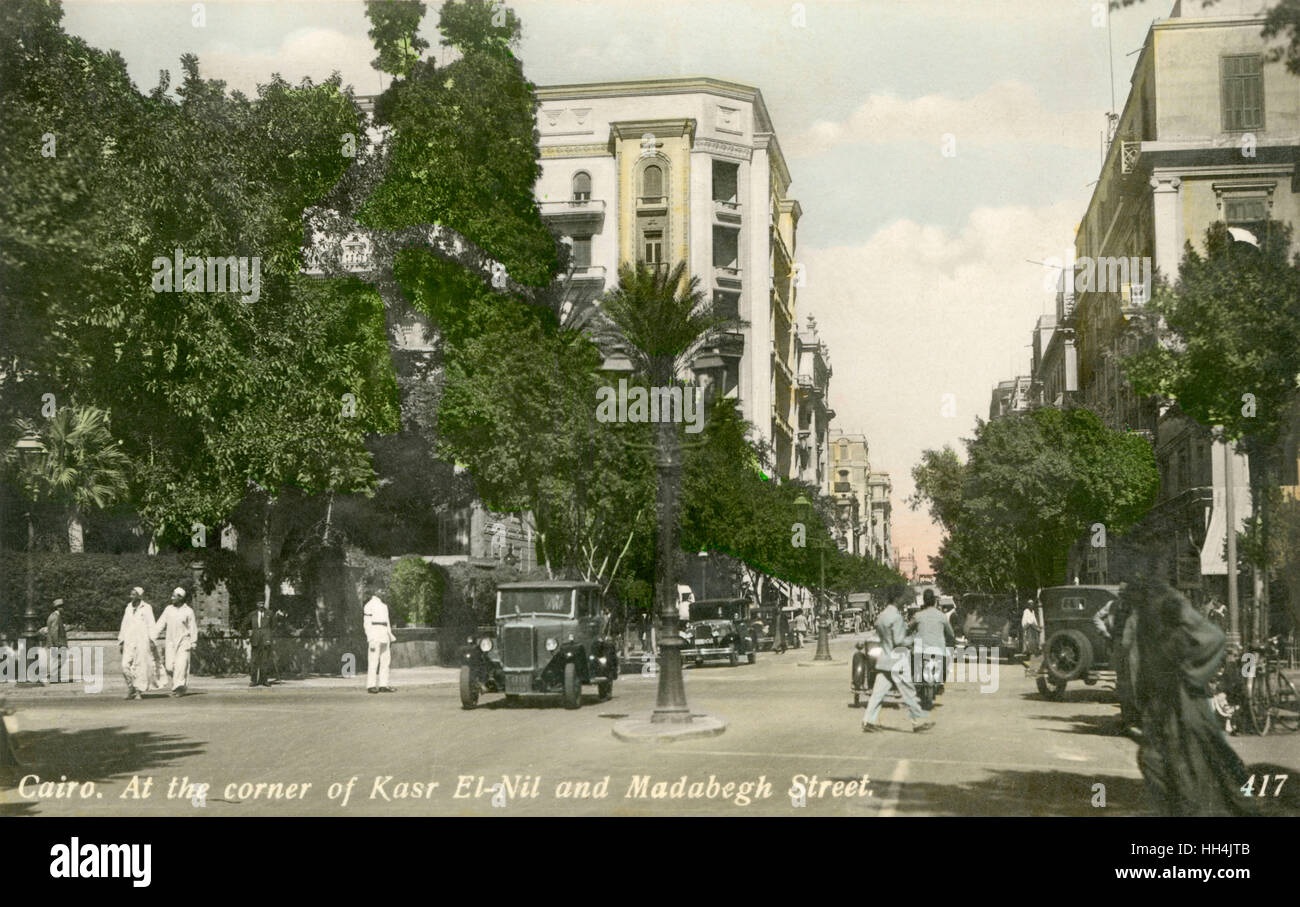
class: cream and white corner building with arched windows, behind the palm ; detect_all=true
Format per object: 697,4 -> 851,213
536,78 -> 806,478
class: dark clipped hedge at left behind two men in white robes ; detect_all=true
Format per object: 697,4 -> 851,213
0,551 -> 256,635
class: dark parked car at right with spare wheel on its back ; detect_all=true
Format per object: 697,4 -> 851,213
1037,586 -> 1123,699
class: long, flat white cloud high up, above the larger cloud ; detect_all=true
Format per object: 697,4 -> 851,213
788,81 -> 1101,157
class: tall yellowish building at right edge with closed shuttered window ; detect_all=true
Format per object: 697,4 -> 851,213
1066,0 -> 1300,589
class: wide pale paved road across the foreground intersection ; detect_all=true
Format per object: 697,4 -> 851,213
0,637 -> 1300,816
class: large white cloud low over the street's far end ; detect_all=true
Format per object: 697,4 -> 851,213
798,200 -> 1079,568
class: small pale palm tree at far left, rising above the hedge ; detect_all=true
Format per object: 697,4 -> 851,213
8,405 -> 131,554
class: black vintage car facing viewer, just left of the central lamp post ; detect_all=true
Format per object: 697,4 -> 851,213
460,581 -> 619,708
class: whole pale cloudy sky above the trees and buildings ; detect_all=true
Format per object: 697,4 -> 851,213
64,0 -> 1173,567
